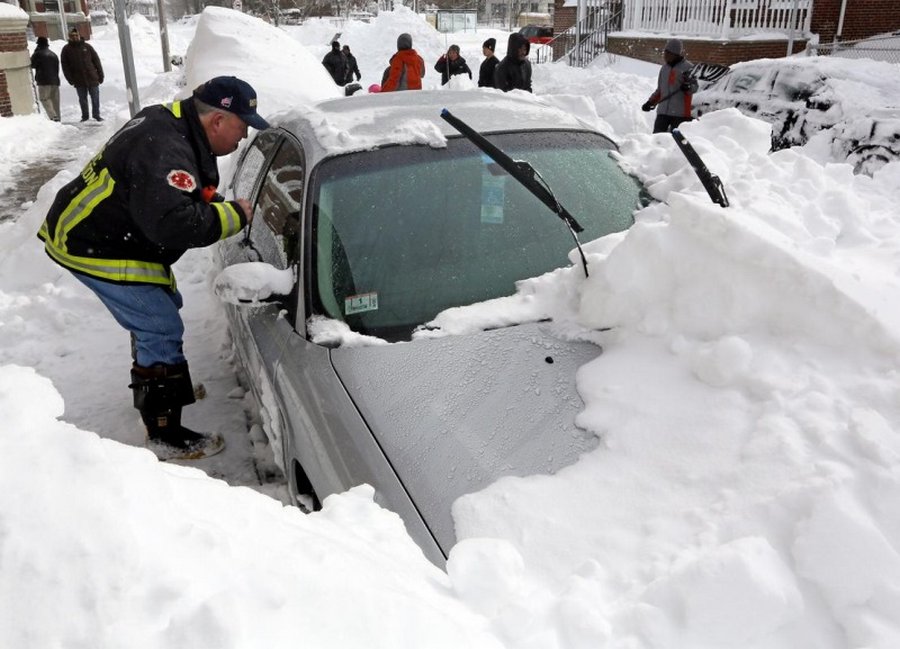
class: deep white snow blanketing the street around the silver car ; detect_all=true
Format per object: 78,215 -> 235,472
0,8 -> 900,649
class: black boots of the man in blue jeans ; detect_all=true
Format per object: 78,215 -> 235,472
130,363 -> 225,460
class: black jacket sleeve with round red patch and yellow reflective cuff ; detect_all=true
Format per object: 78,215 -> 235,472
125,138 -> 247,250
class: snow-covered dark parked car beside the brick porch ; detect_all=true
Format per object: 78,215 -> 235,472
693,57 -> 900,172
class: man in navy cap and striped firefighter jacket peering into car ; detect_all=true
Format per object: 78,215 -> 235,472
38,77 -> 268,459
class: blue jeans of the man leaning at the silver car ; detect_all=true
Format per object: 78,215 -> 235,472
72,273 -> 185,367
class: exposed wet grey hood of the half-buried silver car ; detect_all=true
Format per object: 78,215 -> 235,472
331,323 -> 601,552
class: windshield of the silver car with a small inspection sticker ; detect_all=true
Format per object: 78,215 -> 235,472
311,131 -> 643,340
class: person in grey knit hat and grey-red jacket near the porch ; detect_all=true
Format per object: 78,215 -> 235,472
641,38 -> 698,133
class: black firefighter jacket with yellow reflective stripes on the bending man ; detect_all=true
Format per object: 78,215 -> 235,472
38,100 -> 247,287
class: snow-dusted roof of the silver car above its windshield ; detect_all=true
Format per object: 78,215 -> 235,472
269,90 -> 602,168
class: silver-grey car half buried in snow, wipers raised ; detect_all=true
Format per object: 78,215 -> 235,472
219,90 -> 645,565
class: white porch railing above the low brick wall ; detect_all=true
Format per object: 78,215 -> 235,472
622,0 -> 813,38
